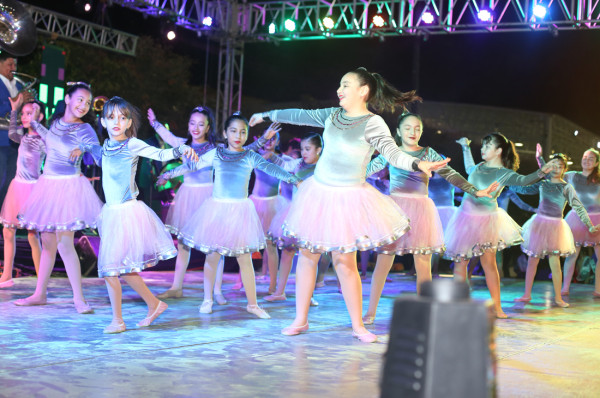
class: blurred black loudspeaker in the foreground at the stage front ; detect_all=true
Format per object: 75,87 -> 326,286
381,279 -> 496,398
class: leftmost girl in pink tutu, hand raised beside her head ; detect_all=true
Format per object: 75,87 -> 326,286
0,94 -> 46,289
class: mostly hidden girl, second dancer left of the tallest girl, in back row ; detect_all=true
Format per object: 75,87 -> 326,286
250,124 -> 287,293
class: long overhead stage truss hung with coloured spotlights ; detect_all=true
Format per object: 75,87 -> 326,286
113,0 -> 600,41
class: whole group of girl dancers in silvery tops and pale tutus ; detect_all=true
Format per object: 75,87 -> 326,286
0,68 -> 600,342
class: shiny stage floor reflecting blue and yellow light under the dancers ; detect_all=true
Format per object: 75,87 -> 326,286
0,272 -> 600,398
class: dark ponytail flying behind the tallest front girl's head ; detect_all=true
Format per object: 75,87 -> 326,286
350,68 -> 422,112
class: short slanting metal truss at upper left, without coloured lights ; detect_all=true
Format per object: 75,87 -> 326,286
26,5 -> 138,55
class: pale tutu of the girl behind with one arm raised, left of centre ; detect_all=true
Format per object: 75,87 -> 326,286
165,182 -> 213,235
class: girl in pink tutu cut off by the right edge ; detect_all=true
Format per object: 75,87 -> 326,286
536,144 -> 600,298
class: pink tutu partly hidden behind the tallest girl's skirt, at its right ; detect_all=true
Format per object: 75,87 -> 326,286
375,193 -> 444,256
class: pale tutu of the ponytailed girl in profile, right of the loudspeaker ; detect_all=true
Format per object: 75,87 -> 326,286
444,206 -> 523,261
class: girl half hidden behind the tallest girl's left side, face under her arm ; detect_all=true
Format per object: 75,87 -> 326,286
265,133 -> 329,301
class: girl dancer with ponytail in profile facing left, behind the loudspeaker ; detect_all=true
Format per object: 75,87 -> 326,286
444,133 -> 556,318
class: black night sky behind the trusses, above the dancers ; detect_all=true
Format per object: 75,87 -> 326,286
25,0 -> 600,134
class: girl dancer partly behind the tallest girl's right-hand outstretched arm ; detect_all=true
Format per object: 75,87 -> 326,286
363,113 -> 498,325
